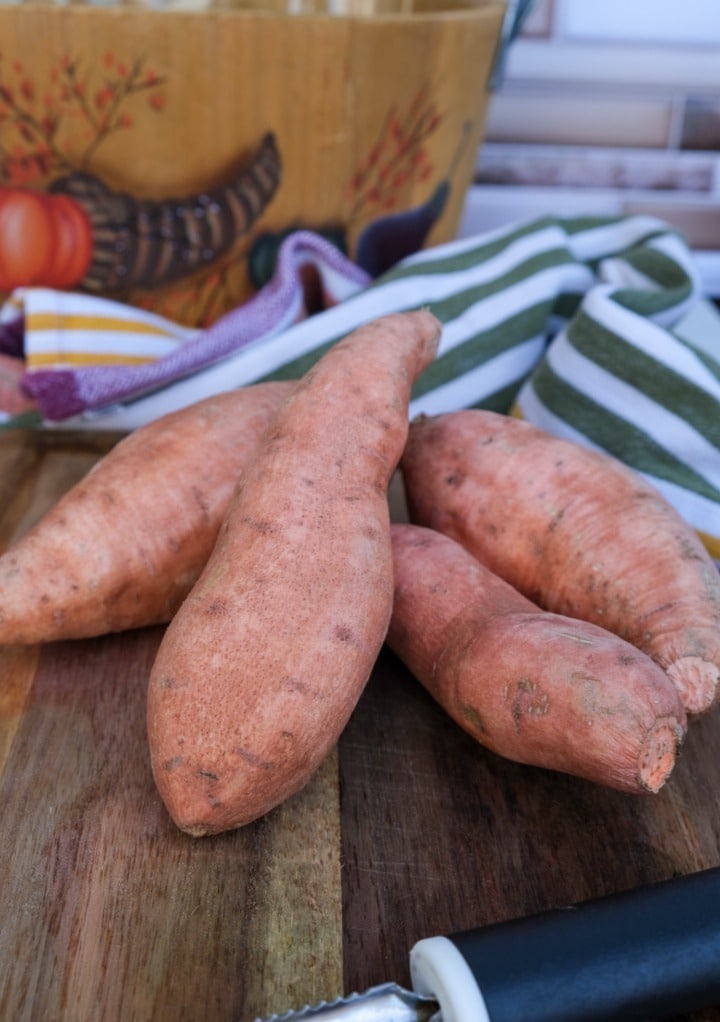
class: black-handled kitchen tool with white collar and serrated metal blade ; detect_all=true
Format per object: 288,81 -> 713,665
255,868 -> 720,1022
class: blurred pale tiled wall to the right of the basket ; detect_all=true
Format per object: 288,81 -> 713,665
474,0 -> 720,250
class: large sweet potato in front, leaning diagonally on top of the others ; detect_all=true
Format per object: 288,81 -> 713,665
147,312 -> 439,836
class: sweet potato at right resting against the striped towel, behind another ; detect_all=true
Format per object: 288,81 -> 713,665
402,410 -> 720,714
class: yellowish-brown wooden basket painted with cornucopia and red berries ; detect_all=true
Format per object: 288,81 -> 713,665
0,0 -> 506,325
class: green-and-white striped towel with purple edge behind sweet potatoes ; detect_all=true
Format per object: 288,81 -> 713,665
2,210 -> 720,556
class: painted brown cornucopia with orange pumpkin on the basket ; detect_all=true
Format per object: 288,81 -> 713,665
0,132 -> 281,294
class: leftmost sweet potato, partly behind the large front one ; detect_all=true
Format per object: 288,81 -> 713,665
0,382 -> 292,644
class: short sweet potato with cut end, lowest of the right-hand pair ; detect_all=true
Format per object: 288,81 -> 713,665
387,523 -> 686,794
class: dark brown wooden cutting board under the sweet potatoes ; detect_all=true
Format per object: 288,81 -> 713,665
0,433 -> 720,1022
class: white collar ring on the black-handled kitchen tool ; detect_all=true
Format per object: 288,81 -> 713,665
410,937 -> 491,1022
